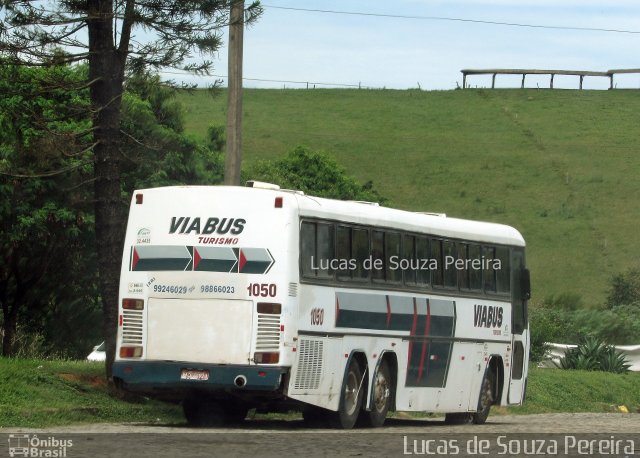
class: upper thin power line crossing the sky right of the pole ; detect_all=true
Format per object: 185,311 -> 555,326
262,4 -> 640,34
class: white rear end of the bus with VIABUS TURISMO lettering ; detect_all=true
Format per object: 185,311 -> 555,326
113,187 -> 297,423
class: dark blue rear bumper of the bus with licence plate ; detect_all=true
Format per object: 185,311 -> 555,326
113,361 -> 288,392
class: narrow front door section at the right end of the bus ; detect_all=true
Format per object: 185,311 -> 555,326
508,248 -> 531,404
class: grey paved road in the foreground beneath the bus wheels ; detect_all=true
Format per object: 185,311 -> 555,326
0,413 -> 640,458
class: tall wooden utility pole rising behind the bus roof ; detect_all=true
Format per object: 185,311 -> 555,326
224,0 -> 244,186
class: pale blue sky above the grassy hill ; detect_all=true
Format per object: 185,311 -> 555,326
162,0 -> 640,90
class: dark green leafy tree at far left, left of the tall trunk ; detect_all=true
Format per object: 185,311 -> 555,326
0,63 -> 96,356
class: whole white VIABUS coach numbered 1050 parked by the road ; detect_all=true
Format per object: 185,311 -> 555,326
113,183 -> 530,428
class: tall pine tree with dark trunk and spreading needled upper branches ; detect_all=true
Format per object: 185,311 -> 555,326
0,0 -> 261,377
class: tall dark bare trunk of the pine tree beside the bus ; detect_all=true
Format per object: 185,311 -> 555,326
88,0 -> 126,378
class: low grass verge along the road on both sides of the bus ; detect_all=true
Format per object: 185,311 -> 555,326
0,358 -> 640,429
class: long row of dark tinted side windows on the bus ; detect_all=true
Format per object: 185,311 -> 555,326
300,221 -> 516,295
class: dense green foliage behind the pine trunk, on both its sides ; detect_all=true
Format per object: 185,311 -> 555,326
0,62 -> 223,357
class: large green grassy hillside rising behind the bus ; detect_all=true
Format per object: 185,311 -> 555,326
175,89 -> 640,306
